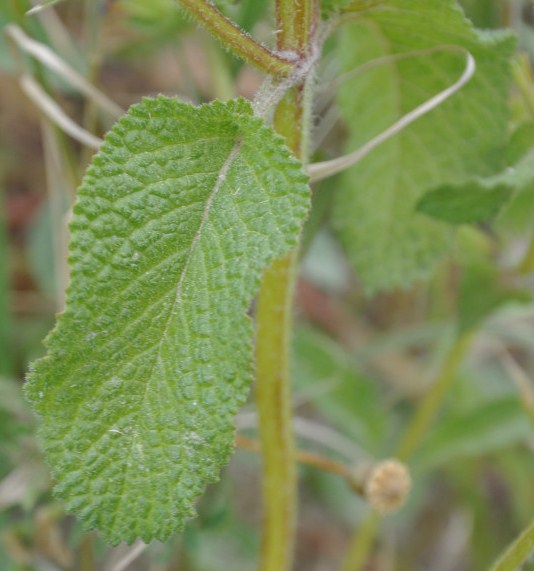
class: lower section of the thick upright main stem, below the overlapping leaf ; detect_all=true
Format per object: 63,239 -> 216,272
256,251 -> 297,571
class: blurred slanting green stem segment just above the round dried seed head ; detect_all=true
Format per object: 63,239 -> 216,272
395,334 -> 472,462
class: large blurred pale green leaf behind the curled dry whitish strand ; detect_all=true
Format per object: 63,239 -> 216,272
333,0 -> 514,292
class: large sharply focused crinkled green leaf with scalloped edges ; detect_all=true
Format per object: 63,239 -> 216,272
27,97 -> 309,543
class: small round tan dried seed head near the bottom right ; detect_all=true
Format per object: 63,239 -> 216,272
364,460 -> 411,513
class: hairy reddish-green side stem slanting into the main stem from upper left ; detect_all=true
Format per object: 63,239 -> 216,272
179,0 -> 295,77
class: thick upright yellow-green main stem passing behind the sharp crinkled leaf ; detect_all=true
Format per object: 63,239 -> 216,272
256,4 -> 316,571
